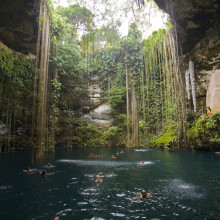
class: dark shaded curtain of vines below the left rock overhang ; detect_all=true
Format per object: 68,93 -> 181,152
0,48 -> 35,152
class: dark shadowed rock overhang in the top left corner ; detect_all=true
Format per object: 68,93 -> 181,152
0,0 -> 41,55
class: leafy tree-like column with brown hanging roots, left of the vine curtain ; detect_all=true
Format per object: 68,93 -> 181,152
121,23 -> 143,146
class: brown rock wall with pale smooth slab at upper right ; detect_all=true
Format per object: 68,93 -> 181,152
154,0 -> 220,111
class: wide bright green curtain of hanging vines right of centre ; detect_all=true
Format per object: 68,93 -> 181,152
141,29 -> 182,146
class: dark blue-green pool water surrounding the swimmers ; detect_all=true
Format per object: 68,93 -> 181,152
0,148 -> 220,220
